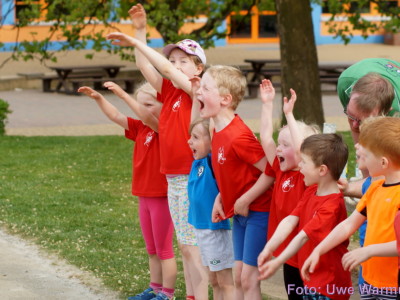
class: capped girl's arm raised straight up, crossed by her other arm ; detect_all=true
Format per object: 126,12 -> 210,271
128,3 -> 162,92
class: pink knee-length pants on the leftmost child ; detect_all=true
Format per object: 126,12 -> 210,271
138,197 -> 174,260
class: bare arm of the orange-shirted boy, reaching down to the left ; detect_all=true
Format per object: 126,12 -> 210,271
301,210 -> 366,280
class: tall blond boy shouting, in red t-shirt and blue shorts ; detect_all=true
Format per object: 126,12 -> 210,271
196,66 -> 273,300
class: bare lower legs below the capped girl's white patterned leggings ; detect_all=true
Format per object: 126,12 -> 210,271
180,245 -> 208,300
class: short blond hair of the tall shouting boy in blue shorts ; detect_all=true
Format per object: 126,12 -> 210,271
206,65 -> 247,110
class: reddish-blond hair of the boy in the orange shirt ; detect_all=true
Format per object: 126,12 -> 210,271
359,117 -> 400,167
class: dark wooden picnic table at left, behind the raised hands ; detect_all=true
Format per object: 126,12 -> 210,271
41,64 -> 134,95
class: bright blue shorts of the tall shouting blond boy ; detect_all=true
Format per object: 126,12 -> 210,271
232,211 -> 269,267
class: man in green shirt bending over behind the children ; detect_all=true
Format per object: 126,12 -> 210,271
337,58 -> 400,143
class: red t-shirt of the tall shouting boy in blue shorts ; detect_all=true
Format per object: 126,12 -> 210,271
211,115 -> 272,218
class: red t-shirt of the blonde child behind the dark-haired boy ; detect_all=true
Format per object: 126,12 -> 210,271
264,157 -> 307,268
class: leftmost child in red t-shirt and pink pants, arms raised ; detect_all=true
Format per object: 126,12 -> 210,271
78,82 -> 177,299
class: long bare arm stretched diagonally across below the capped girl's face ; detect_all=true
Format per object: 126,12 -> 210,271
107,32 -> 192,96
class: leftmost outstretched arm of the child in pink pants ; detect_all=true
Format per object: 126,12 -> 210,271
78,86 -> 129,130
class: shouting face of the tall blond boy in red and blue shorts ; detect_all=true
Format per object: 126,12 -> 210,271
196,72 -> 222,119
